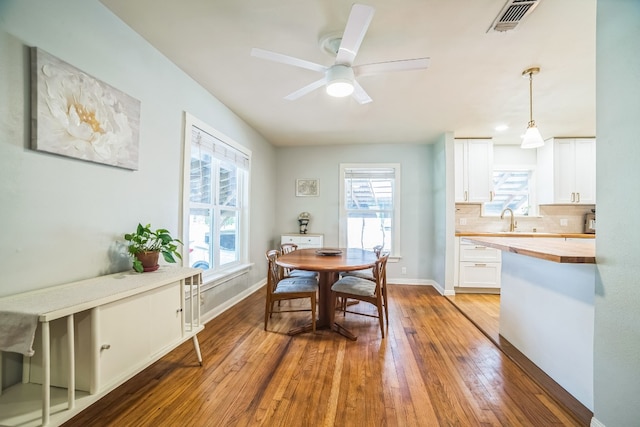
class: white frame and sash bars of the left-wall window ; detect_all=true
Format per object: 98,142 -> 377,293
181,112 -> 251,283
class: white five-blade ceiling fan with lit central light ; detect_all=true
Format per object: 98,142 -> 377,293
251,4 -> 429,104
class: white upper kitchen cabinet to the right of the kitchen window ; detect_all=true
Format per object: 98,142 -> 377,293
538,138 -> 596,205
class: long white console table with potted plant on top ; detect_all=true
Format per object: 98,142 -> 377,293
0,267 -> 204,426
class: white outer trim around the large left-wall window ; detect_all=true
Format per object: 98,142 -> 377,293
180,111 -> 251,284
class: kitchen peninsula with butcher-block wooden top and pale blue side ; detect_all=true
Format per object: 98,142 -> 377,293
461,235 -> 596,411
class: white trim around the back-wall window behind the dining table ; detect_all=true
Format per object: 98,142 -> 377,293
338,163 -> 402,260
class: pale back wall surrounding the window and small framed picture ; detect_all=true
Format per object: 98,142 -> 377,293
272,144 -> 436,282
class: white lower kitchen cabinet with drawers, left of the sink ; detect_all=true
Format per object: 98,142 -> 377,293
457,239 -> 502,288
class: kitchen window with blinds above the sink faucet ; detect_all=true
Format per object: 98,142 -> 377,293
484,168 -> 536,216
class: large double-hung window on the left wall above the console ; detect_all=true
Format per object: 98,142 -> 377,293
184,114 -> 251,277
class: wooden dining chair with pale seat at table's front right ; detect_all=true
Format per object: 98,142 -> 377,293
331,254 -> 389,338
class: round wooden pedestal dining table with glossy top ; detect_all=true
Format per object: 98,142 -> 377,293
276,248 -> 377,340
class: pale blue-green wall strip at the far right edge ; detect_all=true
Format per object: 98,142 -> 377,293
594,0 -> 640,427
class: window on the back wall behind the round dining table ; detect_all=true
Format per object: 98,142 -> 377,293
339,164 -> 400,256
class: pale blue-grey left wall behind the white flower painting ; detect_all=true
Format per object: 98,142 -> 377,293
0,0 -> 276,296
